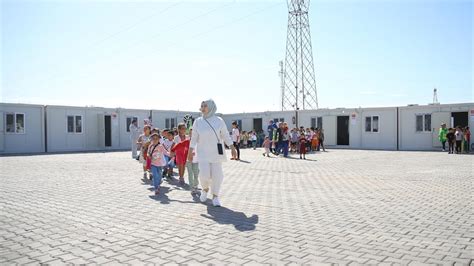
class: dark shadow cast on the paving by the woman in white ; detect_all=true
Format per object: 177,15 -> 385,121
201,205 -> 258,232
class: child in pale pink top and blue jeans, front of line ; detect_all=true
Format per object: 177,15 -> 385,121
148,133 -> 170,195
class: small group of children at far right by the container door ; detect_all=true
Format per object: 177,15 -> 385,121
439,124 -> 471,154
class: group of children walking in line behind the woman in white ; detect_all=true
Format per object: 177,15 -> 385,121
137,123 -> 199,195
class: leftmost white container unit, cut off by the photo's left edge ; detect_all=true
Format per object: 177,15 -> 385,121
0,103 -> 45,154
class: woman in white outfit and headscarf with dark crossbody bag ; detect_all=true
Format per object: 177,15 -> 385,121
188,100 -> 235,207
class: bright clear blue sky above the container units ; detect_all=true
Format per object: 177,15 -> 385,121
0,0 -> 474,113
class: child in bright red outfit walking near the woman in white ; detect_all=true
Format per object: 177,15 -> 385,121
171,123 -> 190,186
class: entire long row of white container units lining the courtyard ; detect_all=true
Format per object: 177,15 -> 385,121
0,103 -> 474,154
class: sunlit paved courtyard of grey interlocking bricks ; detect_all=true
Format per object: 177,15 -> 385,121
0,150 -> 474,265
